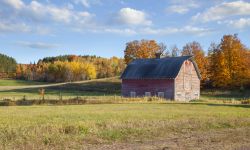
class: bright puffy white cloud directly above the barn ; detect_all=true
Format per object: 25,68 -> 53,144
115,8 -> 152,25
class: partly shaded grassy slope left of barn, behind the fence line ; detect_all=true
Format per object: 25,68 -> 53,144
0,78 -> 121,100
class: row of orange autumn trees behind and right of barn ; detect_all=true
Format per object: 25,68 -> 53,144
124,34 -> 250,88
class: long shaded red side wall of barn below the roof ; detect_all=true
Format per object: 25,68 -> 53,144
122,79 -> 174,99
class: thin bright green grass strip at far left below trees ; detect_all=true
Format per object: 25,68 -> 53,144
0,79 -> 46,86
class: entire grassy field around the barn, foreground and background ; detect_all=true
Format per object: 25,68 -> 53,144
0,78 -> 250,149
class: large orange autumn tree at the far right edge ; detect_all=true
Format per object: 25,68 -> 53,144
209,34 -> 250,88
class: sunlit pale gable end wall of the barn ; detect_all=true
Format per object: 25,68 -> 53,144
174,60 -> 200,101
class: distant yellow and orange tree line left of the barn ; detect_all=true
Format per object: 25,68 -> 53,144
16,55 -> 125,82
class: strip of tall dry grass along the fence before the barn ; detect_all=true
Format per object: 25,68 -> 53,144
0,96 -> 250,106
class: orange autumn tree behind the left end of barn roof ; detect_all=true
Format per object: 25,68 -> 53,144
124,40 -> 165,64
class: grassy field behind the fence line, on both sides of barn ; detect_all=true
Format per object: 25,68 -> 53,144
0,78 -> 250,101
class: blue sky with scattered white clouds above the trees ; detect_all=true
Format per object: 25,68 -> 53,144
0,0 -> 250,63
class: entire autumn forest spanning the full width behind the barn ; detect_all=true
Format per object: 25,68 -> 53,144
0,34 -> 250,89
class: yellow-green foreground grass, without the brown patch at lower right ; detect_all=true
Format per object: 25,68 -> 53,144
0,103 -> 250,149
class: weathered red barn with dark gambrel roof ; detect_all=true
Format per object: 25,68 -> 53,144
121,56 -> 201,101
